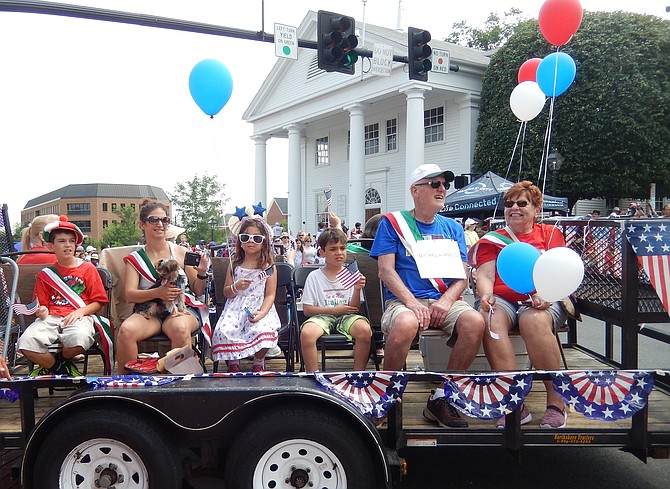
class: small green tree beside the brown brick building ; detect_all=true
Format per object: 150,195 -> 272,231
168,172 -> 229,244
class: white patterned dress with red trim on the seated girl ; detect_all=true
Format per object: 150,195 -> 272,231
212,267 -> 281,361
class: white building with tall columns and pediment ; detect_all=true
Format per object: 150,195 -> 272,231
243,12 -> 489,234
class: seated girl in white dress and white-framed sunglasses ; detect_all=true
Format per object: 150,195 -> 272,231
212,217 -> 281,373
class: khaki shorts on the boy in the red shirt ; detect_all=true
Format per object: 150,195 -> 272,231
17,315 -> 95,353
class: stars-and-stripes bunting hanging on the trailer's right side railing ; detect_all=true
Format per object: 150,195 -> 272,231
624,220 -> 670,312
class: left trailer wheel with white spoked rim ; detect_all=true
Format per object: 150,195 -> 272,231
33,409 -> 182,489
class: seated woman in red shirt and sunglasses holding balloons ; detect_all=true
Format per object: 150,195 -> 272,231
469,181 -> 567,429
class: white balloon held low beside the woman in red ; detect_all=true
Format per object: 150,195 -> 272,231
533,246 -> 584,302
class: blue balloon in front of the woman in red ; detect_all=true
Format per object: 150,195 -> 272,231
496,241 -> 540,294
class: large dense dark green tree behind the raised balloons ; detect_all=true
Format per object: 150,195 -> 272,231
473,12 -> 670,205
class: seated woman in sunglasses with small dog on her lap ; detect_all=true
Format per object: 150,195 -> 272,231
116,200 -> 210,374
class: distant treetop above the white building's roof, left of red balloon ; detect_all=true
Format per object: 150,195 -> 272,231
445,8 -> 522,51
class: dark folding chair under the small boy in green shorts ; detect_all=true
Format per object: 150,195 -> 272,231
291,265 -> 380,372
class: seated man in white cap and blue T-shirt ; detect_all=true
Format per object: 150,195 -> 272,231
370,164 -> 485,428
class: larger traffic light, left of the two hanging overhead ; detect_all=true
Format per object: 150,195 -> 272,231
316,10 -> 358,75
